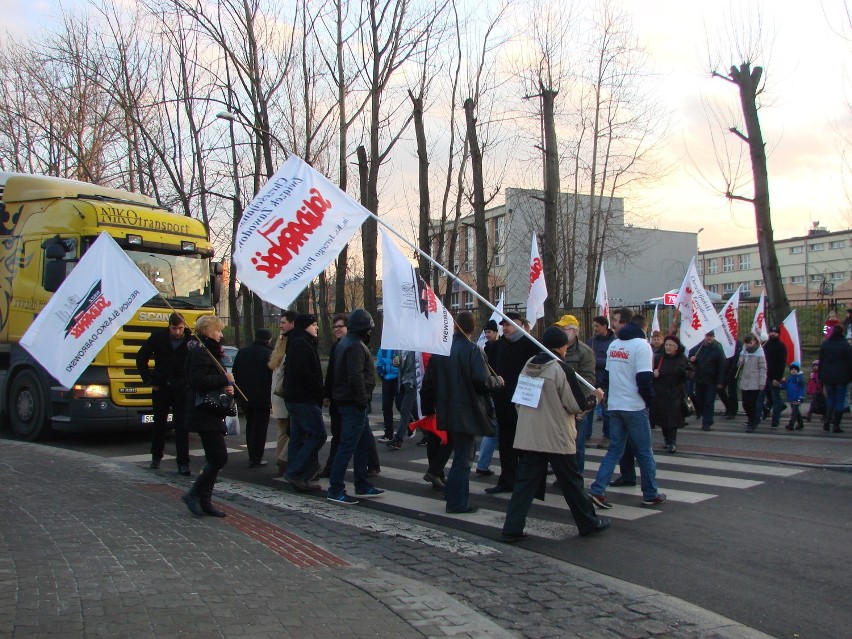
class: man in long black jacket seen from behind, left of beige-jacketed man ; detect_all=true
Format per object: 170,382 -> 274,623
421,311 -> 502,513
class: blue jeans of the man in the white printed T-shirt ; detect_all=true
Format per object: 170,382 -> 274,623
590,408 -> 659,499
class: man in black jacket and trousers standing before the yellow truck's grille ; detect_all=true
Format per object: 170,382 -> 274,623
136,313 -> 192,476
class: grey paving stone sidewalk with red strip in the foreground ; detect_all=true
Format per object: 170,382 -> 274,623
0,441 -> 766,639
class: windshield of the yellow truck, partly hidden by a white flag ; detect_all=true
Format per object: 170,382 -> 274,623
127,251 -> 212,308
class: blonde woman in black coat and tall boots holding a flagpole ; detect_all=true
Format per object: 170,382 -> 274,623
181,315 -> 234,517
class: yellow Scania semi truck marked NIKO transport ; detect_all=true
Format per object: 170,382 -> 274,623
0,172 -> 222,441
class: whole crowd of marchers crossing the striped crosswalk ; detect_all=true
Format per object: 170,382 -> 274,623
137,308 -> 852,542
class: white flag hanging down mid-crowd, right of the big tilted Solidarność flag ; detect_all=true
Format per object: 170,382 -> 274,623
380,229 -> 453,355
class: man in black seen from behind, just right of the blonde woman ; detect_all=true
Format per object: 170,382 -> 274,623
232,328 -> 272,468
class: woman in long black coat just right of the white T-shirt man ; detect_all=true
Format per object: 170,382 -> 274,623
651,335 -> 689,453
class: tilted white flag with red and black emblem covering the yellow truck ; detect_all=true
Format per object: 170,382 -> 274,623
21,233 -> 157,388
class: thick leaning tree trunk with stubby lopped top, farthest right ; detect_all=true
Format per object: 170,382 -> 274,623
728,63 -> 792,324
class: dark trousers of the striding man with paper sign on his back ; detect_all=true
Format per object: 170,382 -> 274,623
503,450 -> 598,535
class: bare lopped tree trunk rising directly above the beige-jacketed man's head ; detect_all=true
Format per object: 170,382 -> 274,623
541,84 -> 560,326
